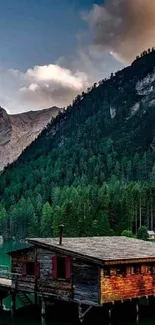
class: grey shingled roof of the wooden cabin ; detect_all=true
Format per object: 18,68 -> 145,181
28,236 -> 155,263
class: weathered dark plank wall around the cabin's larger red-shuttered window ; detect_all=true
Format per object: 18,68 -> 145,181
37,248 -> 99,304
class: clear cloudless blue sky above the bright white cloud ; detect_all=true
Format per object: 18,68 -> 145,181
0,0 -> 98,70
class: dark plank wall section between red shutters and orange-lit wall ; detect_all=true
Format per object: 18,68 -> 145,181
73,261 -> 99,304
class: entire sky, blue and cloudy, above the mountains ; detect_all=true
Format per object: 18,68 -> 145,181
0,0 -> 155,114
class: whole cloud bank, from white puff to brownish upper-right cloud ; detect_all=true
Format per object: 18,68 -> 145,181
0,0 -> 155,113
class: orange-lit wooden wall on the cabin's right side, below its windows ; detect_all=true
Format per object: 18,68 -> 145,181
100,265 -> 155,304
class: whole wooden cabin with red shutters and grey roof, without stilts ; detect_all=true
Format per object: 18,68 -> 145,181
10,237 -> 155,306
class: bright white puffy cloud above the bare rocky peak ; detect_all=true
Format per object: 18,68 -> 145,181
19,64 -> 88,109
